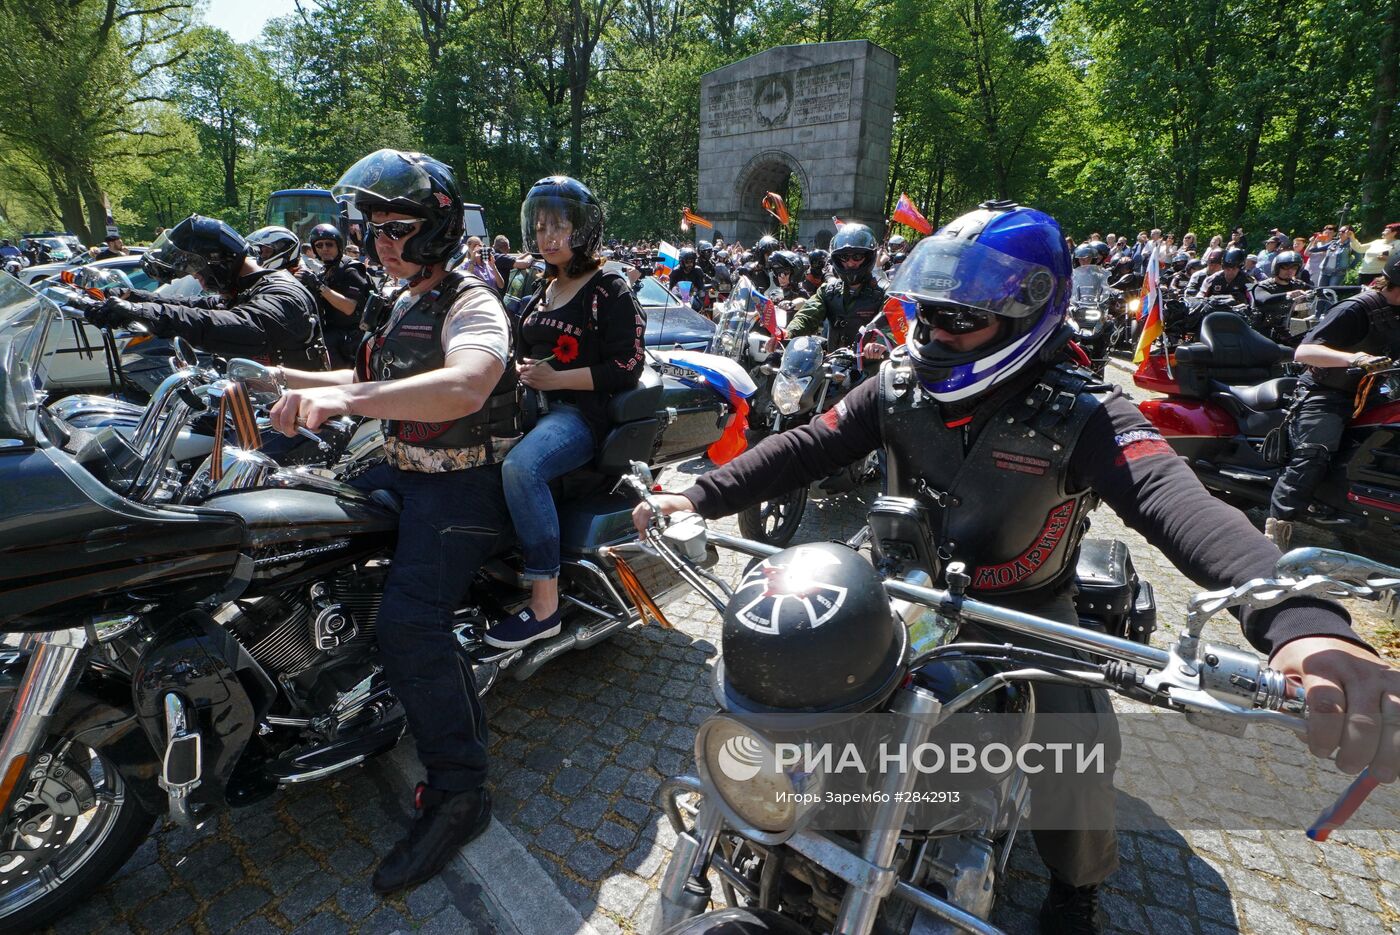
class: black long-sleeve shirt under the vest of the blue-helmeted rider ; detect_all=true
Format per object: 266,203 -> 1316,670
683,379 -> 1365,654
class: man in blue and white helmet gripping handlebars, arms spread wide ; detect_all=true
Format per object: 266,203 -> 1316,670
633,202 -> 1400,934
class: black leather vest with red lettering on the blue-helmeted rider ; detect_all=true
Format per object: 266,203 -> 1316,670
879,349 -> 1102,596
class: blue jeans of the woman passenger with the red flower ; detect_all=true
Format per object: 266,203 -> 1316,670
501,403 -> 594,581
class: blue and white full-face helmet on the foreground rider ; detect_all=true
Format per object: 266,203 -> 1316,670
888,202 -> 1071,403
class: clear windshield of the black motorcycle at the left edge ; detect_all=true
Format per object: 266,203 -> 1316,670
0,276 -> 59,445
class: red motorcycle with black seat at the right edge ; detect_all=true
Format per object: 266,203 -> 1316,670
1133,312 -> 1400,556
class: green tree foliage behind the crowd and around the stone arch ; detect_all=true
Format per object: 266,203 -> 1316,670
0,0 -> 1400,242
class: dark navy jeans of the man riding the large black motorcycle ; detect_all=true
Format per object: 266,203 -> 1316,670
353,465 -> 510,792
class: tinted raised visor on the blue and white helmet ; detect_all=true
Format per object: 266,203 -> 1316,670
888,237 -> 1054,318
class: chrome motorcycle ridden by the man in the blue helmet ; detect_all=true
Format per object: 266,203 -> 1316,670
648,498 -> 1400,935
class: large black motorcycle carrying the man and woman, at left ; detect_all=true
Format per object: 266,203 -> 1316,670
0,280 -> 729,931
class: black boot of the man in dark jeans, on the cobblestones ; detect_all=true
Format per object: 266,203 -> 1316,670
371,782 -> 491,896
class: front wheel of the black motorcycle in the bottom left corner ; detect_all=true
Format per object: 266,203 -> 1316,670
0,738 -> 155,932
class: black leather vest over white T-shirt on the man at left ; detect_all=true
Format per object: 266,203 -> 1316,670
356,272 -> 519,448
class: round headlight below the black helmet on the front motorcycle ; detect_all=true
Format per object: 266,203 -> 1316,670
696,714 -> 822,837
